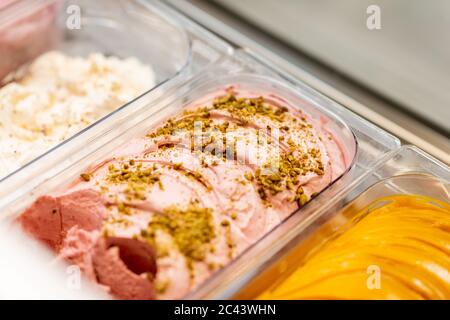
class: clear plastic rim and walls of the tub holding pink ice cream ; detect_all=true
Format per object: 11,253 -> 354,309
0,51 -> 399,298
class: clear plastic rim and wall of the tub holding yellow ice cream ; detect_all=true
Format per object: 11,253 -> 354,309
215,146 -> 450,299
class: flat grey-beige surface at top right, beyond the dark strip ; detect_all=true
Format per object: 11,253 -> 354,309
215,0 -> 450,134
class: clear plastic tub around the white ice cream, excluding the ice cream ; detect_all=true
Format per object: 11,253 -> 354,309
0,0 -> 232,180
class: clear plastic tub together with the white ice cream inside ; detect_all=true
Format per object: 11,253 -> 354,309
0,0 -> 230,179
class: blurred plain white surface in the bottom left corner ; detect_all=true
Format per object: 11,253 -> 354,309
0,224 -> 107,300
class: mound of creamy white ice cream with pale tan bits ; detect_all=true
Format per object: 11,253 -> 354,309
0,51 -> 155,178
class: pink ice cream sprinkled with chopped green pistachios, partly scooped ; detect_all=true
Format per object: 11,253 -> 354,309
19,88 -> 351,299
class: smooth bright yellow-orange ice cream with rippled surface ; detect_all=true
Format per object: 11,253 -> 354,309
258,195 -> 450,299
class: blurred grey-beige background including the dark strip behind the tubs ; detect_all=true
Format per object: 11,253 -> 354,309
176,0 -> 450,159
